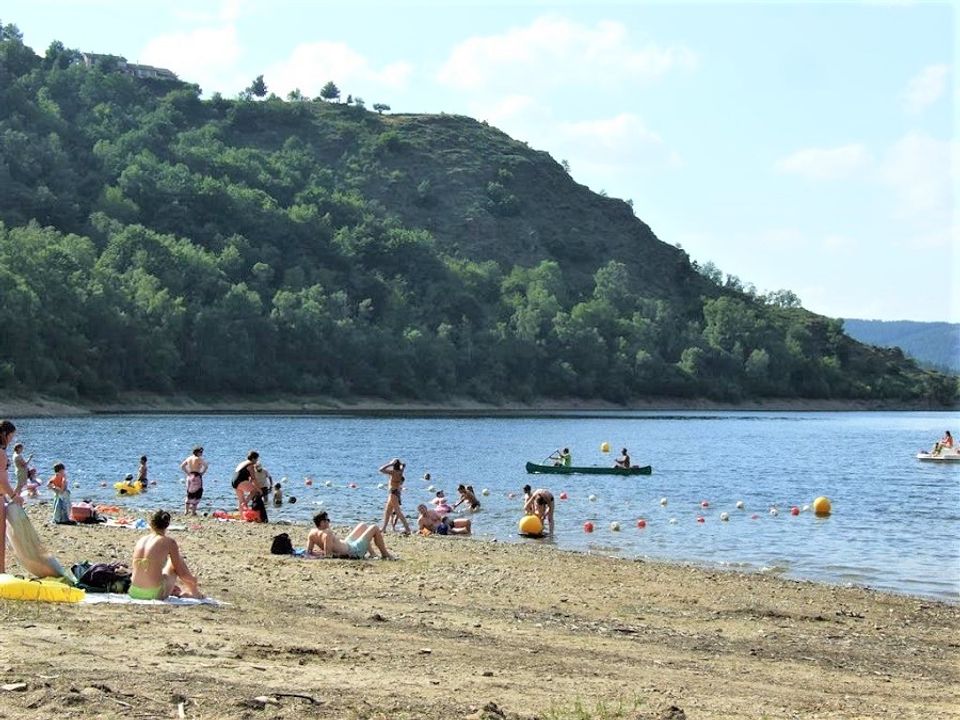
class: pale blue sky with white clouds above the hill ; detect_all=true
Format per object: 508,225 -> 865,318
0,0 -> 960,322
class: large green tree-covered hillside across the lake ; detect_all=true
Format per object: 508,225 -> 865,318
0,25 -> 957,403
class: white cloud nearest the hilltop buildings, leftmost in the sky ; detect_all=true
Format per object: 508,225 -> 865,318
137,25 -> 240,94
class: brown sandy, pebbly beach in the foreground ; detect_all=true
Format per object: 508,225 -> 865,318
0,507 -> 960,720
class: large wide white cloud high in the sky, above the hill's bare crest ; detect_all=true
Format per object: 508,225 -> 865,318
437,16 -> 697,93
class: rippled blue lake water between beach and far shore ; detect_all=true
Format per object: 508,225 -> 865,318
14,411 -> 960,602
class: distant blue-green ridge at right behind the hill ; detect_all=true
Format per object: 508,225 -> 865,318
843,320 -> 960,373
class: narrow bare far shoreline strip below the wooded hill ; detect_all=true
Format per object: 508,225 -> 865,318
0,393 -> 958,418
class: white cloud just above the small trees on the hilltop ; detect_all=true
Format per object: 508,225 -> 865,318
264,42 -> 413,102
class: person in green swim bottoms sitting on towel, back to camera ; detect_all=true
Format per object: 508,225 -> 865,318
129,510 -> 203,600
